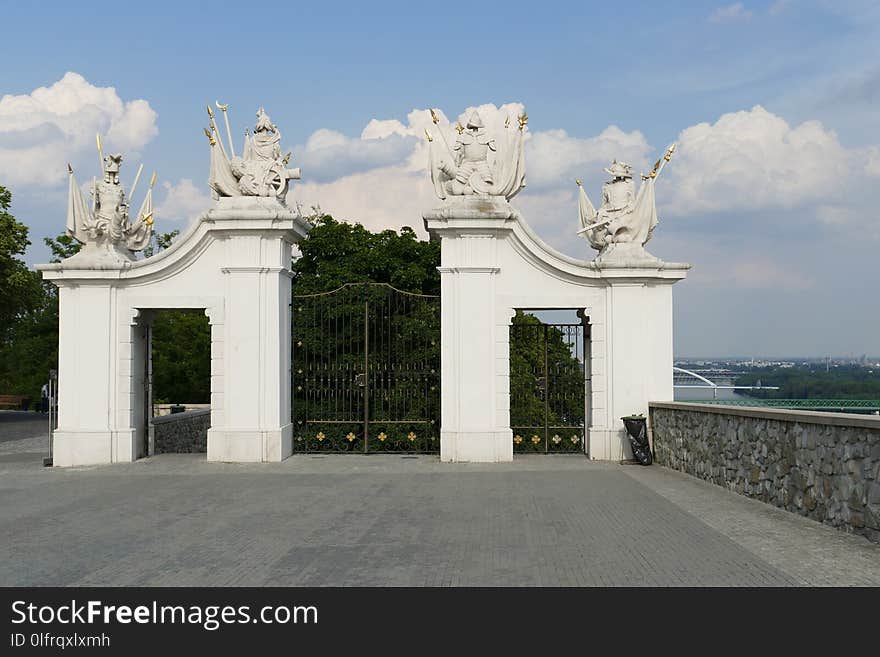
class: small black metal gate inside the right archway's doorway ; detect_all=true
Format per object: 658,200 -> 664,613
510,311 -> 587,454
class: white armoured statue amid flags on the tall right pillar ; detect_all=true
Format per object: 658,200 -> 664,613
425,110 -> 528,200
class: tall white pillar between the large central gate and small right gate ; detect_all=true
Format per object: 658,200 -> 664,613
424,197 -> 513,462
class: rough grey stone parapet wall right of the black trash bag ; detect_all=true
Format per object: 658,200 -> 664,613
650,402 -> 880,542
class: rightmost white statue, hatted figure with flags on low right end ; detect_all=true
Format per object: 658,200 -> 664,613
576,144 -> 675,255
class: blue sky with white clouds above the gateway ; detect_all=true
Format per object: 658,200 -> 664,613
0,0 -> 880,356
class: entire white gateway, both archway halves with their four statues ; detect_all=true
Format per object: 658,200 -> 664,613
38,109 -> 688,466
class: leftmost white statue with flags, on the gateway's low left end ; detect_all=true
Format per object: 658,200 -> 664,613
67,135 -> 156,260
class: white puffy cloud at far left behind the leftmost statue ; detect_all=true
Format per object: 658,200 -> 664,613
0,72 -> 159,186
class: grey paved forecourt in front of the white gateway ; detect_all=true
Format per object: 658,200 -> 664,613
0,412 -> 880,586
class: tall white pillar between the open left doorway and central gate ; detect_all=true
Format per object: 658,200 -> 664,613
205,197 -> 301,462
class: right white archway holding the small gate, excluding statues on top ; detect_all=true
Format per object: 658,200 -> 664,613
424,196 -> 689,462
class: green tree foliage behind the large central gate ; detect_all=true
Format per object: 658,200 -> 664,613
292,212 -> 440,450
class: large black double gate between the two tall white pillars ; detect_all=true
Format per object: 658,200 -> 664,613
292,283 -> 440,454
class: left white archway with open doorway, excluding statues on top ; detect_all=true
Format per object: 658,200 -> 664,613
38,197 -> 309,466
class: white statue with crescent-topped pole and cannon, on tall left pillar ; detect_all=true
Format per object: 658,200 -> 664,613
205,103 -> 300,203
